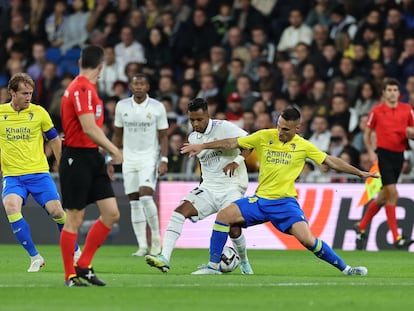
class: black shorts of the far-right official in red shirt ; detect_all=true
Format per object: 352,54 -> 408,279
377,148 -> 404,186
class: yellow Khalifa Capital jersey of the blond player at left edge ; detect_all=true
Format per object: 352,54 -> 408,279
0,103 -> 53,176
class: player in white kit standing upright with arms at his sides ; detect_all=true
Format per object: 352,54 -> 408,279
112,74 -> 168,256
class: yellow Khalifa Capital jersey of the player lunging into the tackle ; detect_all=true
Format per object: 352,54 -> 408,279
237,129 -> 327,199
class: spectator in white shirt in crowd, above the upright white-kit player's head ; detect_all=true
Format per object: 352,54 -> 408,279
115,26 -> 146,64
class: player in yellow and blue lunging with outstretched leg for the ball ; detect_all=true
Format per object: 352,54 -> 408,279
181,107 -> 379,275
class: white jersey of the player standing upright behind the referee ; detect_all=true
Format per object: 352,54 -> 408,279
114,95 -> 168,163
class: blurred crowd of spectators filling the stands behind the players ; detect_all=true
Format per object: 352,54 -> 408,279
0,0 -> 414,182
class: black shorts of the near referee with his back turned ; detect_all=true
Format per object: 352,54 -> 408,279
59,147 -> 115,210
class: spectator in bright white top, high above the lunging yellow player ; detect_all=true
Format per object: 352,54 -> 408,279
277,9 -> 312,60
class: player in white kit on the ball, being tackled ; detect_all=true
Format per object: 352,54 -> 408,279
145,98 -> 253,274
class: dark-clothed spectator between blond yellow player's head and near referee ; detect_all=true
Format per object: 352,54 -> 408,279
33,62 -> 60,110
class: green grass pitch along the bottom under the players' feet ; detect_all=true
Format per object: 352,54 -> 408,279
0,245 -> 414,311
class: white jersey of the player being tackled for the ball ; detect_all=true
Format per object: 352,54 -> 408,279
188,119 -> 248,192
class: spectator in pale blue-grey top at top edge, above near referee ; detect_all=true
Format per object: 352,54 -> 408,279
60,0 -> 91,54
